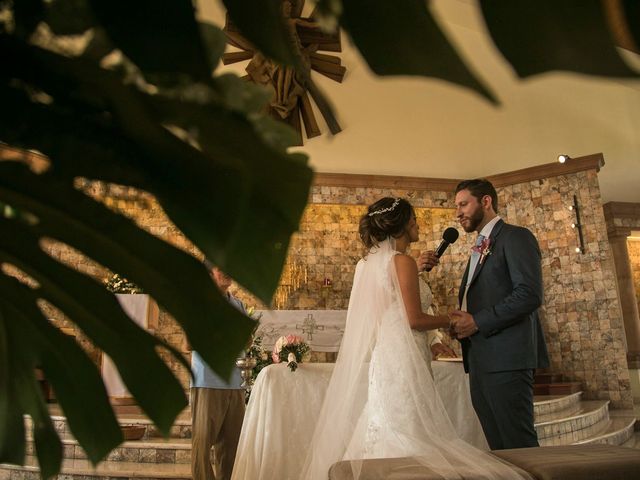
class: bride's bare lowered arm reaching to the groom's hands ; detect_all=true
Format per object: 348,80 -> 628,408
393,255 -> 449,330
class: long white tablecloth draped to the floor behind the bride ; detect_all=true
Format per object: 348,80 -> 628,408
232,362 -> 489,480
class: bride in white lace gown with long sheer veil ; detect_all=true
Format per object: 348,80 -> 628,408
301,197 -> 523,480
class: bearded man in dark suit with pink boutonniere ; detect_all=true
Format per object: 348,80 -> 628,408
451,180 -> 549,450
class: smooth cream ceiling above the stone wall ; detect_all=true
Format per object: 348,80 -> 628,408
200,0 -> 640,203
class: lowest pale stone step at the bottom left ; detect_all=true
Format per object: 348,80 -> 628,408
0,456 -> 191,480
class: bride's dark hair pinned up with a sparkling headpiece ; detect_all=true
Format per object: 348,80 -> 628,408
358,197 -> 413,248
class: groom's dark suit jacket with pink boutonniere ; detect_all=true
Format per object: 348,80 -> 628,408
459,220 -> 549,372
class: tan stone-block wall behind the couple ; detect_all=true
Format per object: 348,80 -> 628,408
15,161 -> 632,408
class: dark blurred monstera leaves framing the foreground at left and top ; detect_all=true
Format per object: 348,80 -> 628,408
0,0 -> 640,478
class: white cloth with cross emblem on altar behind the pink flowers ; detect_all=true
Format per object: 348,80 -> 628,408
256,310 -> 347,352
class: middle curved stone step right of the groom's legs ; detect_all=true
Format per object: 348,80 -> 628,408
535,400 -> 609,439
